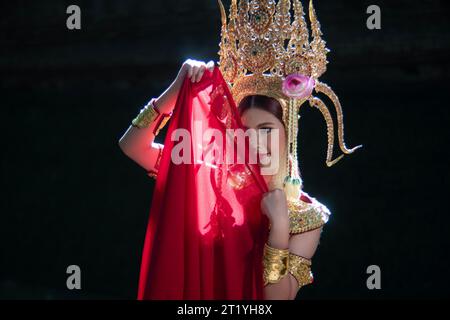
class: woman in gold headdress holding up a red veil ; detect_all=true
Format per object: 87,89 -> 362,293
120,0 -> 361,299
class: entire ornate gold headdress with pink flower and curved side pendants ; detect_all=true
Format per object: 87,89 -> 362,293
218,0 -> 361,199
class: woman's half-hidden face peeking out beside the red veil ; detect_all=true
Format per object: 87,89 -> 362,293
241,108 -> 286,183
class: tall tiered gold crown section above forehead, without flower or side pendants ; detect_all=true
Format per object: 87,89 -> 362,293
219,0 -> 329,104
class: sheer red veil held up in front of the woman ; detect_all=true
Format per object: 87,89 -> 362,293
138,68 -> 268,300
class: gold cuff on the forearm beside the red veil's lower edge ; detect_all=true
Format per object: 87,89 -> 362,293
263,243 -> 289,286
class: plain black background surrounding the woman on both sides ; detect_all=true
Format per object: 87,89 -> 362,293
0,0 -> 450,299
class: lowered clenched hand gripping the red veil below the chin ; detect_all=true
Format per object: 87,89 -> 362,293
261,189 -> 289,232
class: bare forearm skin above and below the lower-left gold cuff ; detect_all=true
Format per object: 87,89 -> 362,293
264,221 -> 291,300
